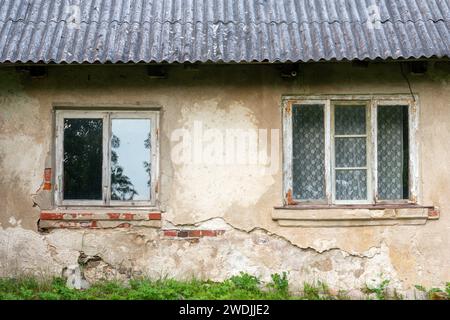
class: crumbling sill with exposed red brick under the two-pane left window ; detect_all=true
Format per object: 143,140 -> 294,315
38,209 -> 161,231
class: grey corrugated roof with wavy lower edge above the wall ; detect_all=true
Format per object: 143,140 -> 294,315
0,0 -> 450,63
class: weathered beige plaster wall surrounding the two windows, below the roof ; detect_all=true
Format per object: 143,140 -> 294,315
0,62 -> 450,298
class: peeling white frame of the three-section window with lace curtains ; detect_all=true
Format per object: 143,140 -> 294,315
281,94 -> 419,206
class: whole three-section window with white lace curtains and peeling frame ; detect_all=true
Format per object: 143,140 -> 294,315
283,95 -> 418,205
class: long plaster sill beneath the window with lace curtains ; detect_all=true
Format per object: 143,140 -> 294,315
272,204 -> 439,227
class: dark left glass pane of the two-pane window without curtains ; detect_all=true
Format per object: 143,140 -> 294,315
63,119 -> 103,200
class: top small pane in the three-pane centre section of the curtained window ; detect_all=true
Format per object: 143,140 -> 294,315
334,105 -> 366,135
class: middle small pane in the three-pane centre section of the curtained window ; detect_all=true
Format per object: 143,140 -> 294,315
335,138 -> 366,168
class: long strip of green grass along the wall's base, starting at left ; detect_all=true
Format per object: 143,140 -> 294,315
0,273 -> 342,300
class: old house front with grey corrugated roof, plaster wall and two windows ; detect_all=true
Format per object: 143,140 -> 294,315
0,0 -> 450,296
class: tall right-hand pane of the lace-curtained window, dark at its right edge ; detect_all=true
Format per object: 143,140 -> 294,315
377,106 -> 409,200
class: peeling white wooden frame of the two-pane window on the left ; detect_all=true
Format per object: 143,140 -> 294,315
54,109 -> 159,208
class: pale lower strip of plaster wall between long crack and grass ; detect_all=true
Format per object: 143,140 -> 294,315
0,227 -> 402,293
